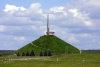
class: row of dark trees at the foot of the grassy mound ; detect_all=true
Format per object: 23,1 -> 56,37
17,50 -> 52,56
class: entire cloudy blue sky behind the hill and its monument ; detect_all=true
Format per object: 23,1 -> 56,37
0,0 -> 100,50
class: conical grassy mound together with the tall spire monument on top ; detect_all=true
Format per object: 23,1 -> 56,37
16,15 -> 80,56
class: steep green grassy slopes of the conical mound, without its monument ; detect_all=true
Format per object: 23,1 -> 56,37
16,35 -> 80,56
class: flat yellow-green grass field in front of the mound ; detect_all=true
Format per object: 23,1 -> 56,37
0,54 -> 100,67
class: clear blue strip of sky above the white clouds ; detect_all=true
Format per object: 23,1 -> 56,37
0,0 -> 71,9
